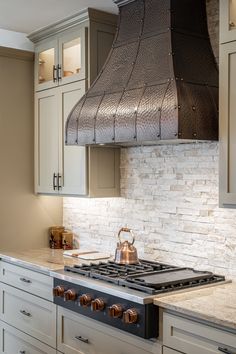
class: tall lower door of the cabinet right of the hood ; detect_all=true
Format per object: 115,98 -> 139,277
220,42 -> 236,207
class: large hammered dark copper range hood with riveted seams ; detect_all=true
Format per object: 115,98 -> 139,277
66,0 -> 218,146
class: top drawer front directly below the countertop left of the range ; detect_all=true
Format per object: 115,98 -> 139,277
0,262 -> 53,301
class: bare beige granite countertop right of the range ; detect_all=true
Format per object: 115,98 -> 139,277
154,282 -> 236,330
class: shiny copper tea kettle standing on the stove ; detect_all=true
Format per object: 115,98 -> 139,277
114,227 -> 139,264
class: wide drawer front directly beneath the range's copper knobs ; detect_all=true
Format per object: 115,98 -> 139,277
57,307 -> 162,354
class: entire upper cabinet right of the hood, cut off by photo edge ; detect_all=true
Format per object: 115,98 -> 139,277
219,0 -> 236,208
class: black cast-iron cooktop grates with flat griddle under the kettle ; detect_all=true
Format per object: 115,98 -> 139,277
64,260 -> 225,295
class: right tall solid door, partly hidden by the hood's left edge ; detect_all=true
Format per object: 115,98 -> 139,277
59,81 -> 87,195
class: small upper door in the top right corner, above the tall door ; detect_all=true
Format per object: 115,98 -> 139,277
220,0 -> 236,43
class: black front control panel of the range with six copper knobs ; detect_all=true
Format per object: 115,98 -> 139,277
53,279 -> 158,339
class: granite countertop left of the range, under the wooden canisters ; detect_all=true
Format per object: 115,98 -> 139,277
0,248 -> 97,275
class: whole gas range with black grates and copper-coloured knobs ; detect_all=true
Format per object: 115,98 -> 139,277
54,260 -> 225,339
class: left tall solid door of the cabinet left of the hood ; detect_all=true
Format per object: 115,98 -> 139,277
35,89 -> 59,194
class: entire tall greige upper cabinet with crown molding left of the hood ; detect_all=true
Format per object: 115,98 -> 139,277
29,8 -> 119,197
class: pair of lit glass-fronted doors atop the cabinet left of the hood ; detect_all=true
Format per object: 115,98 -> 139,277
35,27 -> 87,91
